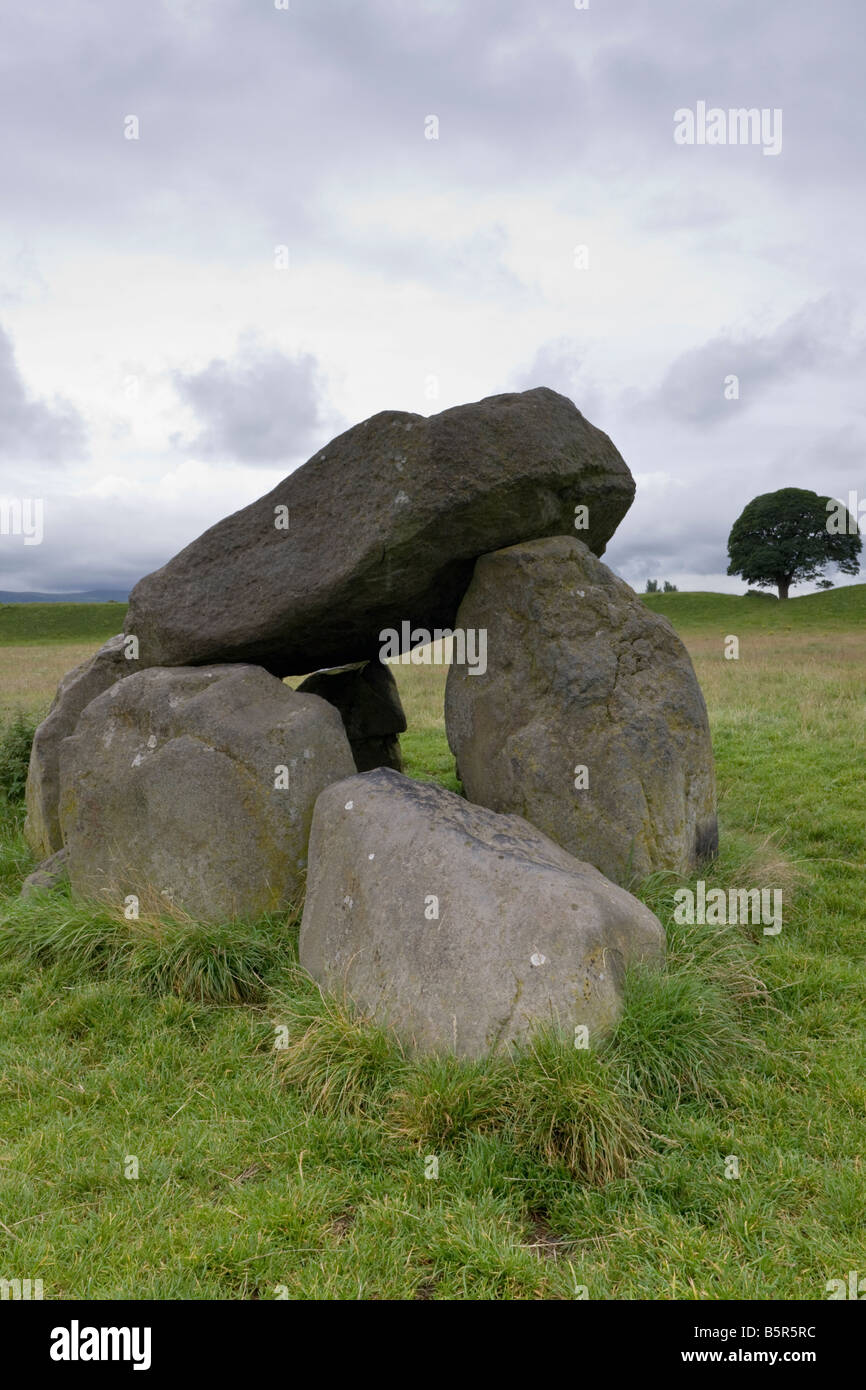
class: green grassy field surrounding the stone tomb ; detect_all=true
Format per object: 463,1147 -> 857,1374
0,585 -> 866,1300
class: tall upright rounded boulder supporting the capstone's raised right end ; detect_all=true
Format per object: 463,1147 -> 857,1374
445,537 -> 719,883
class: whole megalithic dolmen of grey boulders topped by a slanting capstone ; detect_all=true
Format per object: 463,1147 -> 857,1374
25,388 -> 717,1056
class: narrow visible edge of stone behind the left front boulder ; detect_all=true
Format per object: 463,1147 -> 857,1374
24,634 -> 138,859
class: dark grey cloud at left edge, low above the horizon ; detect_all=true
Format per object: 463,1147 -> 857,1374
0,328 -> 86,463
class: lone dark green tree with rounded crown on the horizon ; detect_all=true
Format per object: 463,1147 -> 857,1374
727,488 -> 862,599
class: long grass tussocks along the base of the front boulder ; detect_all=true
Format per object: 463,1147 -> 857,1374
275,990 -> 646,1183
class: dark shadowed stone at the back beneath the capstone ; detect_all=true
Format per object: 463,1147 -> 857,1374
297,660 -> 406,773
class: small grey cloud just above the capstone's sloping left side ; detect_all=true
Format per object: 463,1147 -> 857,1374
172,336 -> 336,463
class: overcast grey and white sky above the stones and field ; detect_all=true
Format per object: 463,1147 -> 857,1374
0,0 -> 866,592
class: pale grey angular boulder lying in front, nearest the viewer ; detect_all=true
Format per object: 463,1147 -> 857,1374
300,769 -> 664,1056
